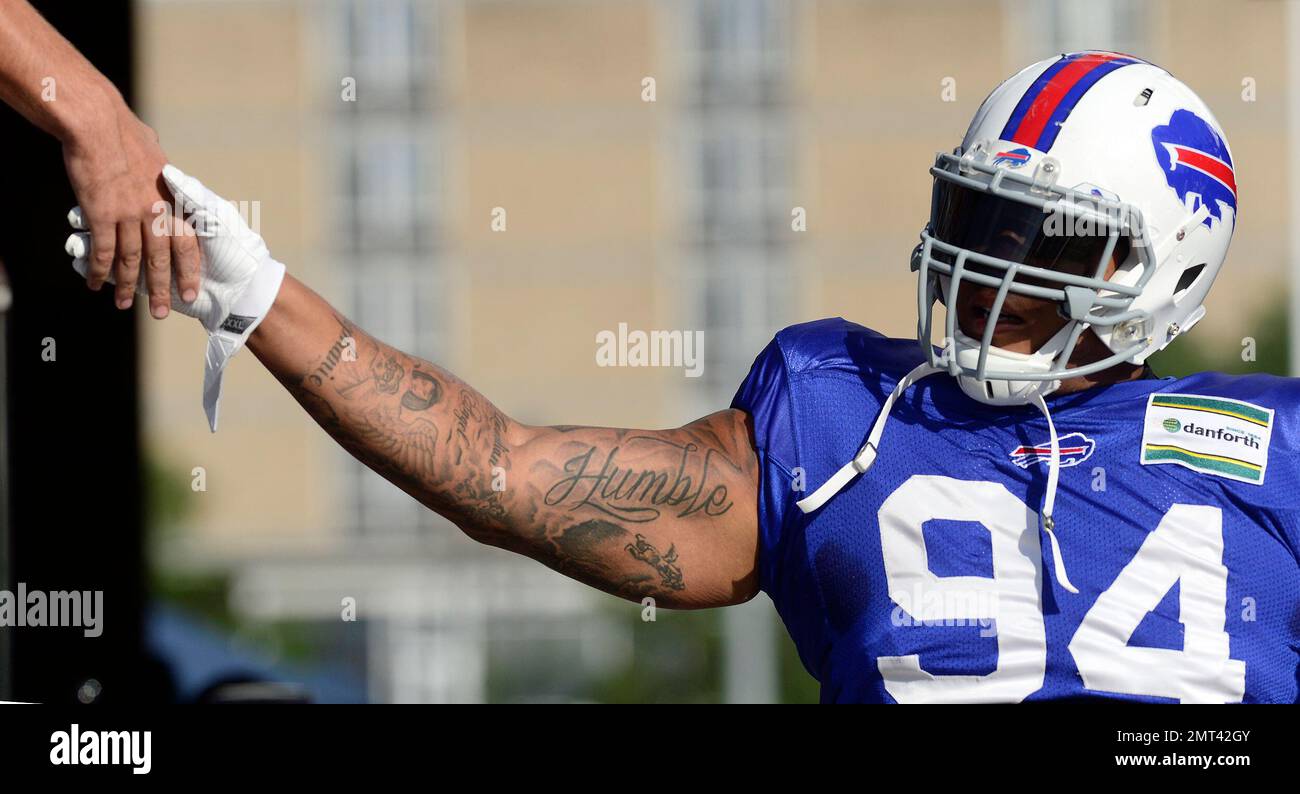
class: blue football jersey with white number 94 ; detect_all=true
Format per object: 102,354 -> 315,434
733,318 -> 1300,703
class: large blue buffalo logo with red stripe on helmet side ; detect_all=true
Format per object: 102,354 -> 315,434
1151,110 -> 1236,226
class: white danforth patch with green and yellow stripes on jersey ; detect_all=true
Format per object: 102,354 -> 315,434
1141,392 -> 1273,485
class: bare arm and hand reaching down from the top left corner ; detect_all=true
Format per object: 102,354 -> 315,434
0,0 -> 199,317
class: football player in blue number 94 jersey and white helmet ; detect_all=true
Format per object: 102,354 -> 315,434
69,52 -> 1300,703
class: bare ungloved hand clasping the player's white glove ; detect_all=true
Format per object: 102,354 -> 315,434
64,107 -> 199,318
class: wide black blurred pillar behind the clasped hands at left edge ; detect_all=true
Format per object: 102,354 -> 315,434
0,0 -> 150,703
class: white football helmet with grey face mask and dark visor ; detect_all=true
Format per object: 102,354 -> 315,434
911,52 -> 1236,404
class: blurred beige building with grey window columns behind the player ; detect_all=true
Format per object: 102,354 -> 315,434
137,0 -> 1287,700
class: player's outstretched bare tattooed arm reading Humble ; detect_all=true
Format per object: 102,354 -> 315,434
248,275 -> 758,608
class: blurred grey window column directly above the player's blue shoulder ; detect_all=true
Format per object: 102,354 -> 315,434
683,0 -> 793,404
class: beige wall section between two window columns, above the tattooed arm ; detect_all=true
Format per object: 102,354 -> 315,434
449,1 -> 681,425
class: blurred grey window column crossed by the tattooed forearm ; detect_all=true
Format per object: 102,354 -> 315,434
332,0 -> 446,539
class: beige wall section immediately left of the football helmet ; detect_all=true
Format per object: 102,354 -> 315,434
796,0 -> 1006,335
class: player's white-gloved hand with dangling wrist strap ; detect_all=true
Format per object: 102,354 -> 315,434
65,165 -> 285,431
